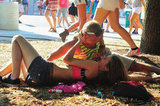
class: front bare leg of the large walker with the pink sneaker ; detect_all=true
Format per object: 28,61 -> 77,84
108,8 -> 137,48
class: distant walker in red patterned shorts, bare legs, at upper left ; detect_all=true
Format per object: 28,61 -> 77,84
45,0 -> 58,32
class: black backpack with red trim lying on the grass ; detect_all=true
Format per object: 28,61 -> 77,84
112,81 -> 155,101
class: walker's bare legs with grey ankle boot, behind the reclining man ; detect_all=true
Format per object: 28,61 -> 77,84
59,0 -> 88,42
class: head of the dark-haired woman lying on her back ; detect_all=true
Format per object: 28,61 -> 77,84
98,55 -> 128,84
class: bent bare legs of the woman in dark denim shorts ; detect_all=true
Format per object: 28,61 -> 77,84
12,35 -> 39,78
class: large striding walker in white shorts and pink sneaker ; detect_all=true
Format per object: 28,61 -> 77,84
93,0 -> 141,56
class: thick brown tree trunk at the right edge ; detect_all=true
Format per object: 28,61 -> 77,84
140,0 -> 160,55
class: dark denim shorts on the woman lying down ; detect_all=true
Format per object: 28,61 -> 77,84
25,56 -> 54,85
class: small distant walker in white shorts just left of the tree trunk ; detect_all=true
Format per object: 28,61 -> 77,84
129,0 -> 145,34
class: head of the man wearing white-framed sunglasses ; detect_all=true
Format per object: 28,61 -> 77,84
81,20 -> 103,44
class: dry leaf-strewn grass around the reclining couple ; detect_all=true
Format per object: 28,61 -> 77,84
0,39 -> 160,106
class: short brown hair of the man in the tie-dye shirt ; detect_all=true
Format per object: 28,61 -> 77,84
82,20 -> 103,36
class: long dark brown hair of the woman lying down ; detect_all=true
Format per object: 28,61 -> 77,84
96,55 -> 128,85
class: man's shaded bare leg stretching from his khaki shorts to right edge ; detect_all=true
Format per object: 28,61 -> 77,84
129,62 -> 160,75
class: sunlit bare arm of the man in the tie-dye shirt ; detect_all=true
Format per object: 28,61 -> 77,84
47,38 -> 78,61
